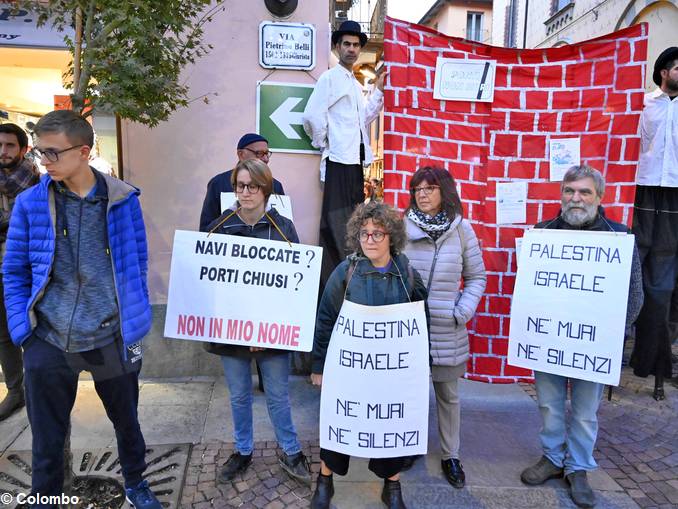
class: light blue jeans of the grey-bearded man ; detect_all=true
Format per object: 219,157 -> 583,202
534,371 -> 604,475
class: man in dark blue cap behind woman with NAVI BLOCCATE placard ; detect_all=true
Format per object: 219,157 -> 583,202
200,133 -> 285,231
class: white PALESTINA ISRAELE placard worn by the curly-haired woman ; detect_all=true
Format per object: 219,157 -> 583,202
320,300 -> 429,458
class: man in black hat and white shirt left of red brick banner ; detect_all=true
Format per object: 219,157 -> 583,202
303,21 -> 384,289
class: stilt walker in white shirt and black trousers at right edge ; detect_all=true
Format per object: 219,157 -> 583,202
630,47 -> 678,401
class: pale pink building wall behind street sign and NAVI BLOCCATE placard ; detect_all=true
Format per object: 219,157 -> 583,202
122,0 -> 330,376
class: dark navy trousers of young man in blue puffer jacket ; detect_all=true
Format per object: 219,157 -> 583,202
24,336 -> 146,495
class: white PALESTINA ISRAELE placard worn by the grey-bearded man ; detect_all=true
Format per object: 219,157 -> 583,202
508,229 -> 634,385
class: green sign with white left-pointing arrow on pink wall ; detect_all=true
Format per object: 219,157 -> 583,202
257,82 -> 319,154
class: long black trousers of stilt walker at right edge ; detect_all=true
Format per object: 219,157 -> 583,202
630,186 -> 678,378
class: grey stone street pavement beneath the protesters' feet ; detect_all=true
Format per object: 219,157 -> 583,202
0,360 -> 678,509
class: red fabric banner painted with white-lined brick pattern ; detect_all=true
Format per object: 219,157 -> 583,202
384,18 -> 647,383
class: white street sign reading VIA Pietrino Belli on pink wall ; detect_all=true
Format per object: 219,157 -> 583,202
259,21 -> 316,71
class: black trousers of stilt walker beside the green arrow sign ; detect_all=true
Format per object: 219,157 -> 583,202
318,159 -> 365,295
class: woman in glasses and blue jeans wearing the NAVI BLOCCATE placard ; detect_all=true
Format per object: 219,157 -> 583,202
206,159 -> 311,484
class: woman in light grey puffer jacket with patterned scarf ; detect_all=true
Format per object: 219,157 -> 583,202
405,167 -> 486,488
